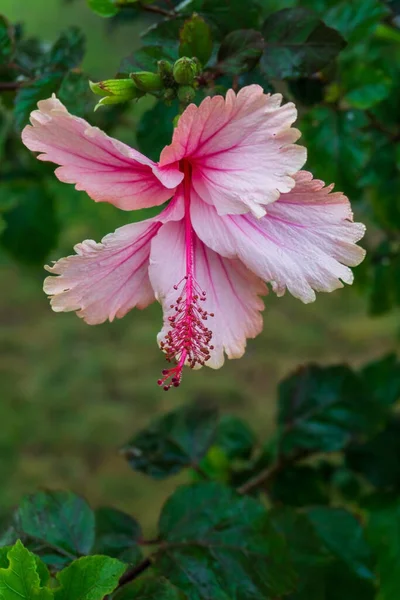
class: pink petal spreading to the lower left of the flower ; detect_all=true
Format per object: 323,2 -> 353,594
43,196 -> 183,325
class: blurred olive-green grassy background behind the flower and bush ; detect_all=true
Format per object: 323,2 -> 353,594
0,0 -> 400,536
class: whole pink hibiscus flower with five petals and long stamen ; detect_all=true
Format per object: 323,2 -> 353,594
22,85 -> 364,389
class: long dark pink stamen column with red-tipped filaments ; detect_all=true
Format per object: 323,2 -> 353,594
158,161 -> 214,391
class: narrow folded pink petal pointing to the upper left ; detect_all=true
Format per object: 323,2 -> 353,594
22,96 -> 182,210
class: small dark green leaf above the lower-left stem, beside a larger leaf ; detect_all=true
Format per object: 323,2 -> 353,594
94,507 -> 142,564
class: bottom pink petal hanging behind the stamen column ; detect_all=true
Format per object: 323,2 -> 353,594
149,221 -> 267,369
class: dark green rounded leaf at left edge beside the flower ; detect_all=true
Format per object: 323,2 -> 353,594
0,181 -> 59,264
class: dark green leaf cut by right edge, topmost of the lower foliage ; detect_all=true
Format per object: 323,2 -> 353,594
361,354 -> 400,406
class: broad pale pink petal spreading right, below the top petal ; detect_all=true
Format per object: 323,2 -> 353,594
192,171 -> 365,302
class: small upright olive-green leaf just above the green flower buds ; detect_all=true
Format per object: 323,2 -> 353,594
179,14 -> 213,66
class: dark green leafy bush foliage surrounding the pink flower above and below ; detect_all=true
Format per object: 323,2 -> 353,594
0,0 -> 400,600
